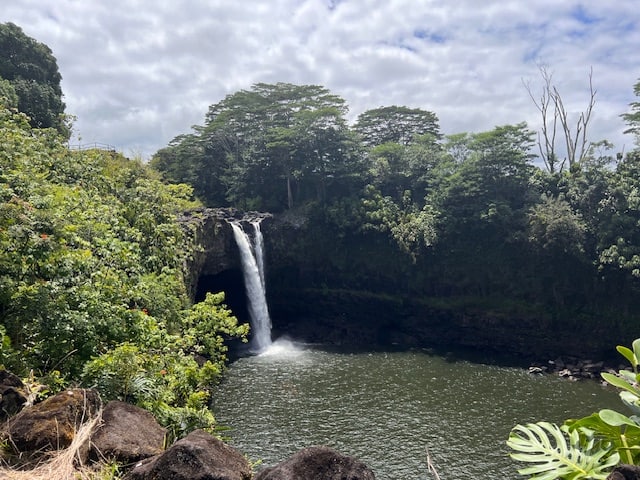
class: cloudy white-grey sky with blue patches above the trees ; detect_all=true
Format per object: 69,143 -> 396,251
0,0 -> 640,159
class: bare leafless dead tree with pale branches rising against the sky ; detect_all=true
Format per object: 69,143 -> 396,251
523,66 -> 596,173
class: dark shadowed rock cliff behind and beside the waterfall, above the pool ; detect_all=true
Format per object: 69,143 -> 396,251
183,209 -> 626,360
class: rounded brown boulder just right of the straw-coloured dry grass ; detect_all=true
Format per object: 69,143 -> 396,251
91,401 -> 167,464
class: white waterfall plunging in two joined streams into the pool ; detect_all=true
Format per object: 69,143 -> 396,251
230,221 -> 272,352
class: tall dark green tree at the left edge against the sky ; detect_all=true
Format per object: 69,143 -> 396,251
0,22 -> 69,138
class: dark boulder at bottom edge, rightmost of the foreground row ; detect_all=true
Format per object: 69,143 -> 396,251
256,447 -> 375,480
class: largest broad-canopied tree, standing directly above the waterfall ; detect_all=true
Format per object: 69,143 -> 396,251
152,83 -> 357,211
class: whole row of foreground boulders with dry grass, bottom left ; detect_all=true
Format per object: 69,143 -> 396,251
0,370 -> 375,480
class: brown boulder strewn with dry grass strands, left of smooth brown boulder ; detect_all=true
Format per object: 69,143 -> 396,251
3,389 -> 102,453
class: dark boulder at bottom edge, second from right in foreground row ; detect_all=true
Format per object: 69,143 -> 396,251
126,430 -> 252,480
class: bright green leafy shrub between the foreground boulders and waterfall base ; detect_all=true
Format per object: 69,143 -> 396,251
82,293 -> 248,438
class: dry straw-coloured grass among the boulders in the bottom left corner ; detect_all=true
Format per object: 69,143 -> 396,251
0,412 -> 112,480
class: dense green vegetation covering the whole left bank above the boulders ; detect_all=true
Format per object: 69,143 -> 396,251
0,24 -> 248,437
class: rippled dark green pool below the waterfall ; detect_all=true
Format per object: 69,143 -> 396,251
214,347 -> 621,480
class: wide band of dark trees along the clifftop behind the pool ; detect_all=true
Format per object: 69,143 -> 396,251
151,79 -> 640,334
